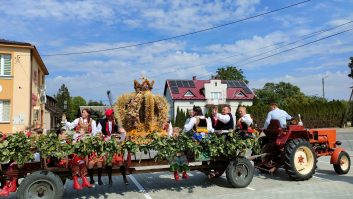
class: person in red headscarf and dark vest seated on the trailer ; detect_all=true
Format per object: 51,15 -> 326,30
97,109 -> 129,186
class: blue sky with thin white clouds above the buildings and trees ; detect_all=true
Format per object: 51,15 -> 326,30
0,0 -> 353,103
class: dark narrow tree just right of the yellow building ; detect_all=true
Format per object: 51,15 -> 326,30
54,84 -> 73,120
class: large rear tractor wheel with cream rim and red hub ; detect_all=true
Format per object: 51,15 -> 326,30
284,138 -> 317,181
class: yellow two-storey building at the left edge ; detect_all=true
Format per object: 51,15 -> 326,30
0,39 -> 49,133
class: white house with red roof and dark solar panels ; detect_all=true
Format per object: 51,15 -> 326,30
164,76 -> 255,119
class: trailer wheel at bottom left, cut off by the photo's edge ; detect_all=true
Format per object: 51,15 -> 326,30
16,171 -> 64,199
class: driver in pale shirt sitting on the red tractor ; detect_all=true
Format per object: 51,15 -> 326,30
264,103 -> 292,129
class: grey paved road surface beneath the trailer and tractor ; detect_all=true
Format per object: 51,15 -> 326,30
7,128 -> 353,199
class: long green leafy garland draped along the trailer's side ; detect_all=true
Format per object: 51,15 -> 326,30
0,132 -> 259,165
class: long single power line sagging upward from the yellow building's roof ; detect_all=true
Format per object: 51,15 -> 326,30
42,0 -> 311,57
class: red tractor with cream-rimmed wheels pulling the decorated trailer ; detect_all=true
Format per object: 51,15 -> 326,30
255,120 -> 351,181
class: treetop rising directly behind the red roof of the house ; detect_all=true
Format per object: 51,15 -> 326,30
215,66 -> 249,84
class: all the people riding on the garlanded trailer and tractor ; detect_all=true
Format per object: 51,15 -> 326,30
0,103 -> 290,196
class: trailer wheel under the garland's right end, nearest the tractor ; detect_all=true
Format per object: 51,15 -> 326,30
226,157 -> 254,188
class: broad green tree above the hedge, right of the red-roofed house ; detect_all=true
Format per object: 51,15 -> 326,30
254,82 -> 309,105
